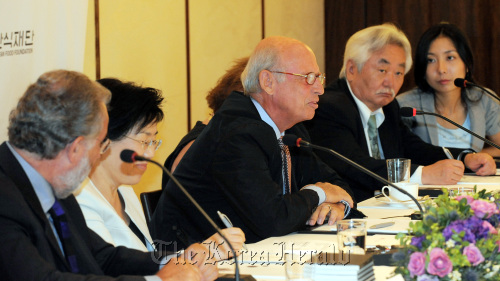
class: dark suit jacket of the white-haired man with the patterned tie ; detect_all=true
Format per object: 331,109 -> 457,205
305,79 -> 462,202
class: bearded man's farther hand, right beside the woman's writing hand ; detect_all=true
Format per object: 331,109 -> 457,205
184,243 -> 219,281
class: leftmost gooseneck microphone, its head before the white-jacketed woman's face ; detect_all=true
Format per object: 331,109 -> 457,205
120,149 -> 255,281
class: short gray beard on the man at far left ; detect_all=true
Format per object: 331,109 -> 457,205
54,154 -> 91,199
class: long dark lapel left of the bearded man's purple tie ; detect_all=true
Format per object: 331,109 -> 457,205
0,142 -> 69,270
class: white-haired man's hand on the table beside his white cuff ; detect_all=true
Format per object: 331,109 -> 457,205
422,159 -> 465,184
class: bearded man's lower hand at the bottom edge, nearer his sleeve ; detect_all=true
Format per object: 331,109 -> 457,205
156,257 -> 202,281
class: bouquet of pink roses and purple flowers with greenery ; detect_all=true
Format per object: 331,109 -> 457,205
393,189 -> 500,281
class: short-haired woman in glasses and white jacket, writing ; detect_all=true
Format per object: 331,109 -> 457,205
75,78 -> 245,259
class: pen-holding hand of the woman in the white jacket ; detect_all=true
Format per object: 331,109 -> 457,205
202,227 -> 245,261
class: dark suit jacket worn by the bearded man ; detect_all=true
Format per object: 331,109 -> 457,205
0,143 -> 159,280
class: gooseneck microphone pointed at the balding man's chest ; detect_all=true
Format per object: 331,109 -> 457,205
283,134 -> 424,215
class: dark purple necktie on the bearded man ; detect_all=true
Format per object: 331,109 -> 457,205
49,199 -> 78,273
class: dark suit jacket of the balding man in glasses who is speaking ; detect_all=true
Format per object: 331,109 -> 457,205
153,92 -> 352,245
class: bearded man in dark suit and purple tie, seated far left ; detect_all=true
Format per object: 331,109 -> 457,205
0,70 -> 217,280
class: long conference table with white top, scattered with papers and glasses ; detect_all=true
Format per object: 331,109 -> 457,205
219,169 -> 500,281
